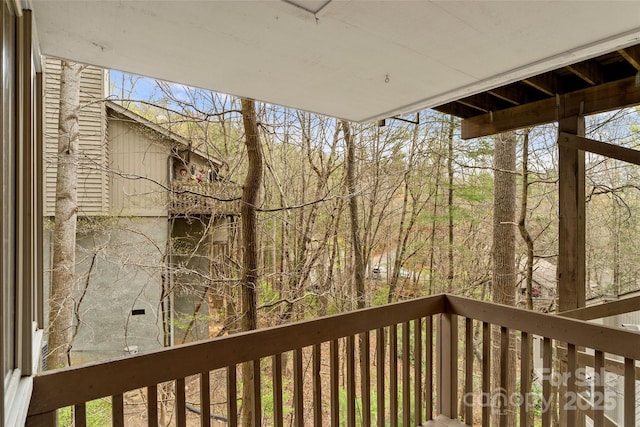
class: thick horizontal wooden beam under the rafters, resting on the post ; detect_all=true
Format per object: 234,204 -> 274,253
462,77 -> 640,139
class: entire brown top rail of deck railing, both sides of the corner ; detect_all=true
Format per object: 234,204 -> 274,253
29,295 -> 640,415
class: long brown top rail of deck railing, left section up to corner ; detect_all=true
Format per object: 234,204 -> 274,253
29,295 -> 446,416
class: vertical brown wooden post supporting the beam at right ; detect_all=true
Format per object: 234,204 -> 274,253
558,115 -> 586,311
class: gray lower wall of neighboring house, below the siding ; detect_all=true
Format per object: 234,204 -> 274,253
45,217 -> 168,364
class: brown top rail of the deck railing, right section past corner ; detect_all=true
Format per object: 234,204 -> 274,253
445,295 -> 640,360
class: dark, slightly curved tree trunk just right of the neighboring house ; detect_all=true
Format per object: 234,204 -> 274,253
240,98 -> 262,427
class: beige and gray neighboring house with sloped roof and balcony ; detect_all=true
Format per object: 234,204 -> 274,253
44,59 -> 240,361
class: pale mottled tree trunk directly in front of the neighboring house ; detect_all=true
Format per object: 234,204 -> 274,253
47,61 -> 82,369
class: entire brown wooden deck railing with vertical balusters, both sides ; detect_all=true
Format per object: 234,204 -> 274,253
29,295 -> 640,426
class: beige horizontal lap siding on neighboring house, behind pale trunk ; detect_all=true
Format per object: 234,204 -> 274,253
44,58 -> 109,216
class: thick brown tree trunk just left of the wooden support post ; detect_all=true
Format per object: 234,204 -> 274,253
491,132 -> 516,426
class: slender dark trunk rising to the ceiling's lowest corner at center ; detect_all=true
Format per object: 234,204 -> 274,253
341,120 -> 364,308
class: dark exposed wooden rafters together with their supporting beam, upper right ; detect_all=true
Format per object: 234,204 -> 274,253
435,45 -> 640,139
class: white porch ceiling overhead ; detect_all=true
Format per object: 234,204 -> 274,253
27,0 -> 640,122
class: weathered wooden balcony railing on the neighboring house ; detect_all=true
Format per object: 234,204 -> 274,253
170,180 -> 242,215
